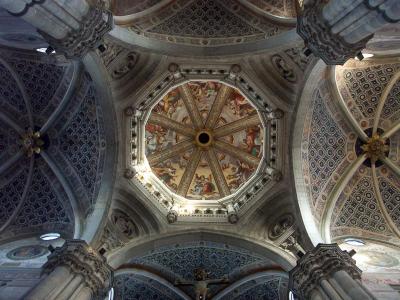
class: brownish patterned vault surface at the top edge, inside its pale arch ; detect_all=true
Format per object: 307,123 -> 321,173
113,0 -> 294,47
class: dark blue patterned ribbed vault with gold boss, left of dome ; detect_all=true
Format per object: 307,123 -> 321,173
0,51 -> 105,237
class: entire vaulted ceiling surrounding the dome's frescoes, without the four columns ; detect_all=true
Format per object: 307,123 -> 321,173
0,0 -> 400,299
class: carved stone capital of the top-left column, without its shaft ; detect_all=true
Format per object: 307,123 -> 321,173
40,5 -> 113,58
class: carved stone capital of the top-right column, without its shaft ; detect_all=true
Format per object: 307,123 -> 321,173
297,0 -> 371,65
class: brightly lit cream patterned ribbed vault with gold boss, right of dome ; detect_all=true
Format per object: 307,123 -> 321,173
302,60 -> 400,243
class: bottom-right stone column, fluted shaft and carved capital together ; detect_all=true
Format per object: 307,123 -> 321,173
289,244 -> 376,300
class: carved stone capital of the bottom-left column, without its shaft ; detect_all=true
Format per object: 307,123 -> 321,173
43,240 -> 113,297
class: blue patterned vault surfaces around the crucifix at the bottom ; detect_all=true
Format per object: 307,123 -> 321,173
115,241 -> 287,299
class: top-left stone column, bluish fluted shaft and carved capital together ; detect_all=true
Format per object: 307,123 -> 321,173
0,0 -> 113,58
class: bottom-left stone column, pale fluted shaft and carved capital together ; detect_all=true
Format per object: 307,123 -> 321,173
24,240 -> 113,300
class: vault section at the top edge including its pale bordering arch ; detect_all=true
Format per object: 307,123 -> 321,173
110,0 -> 295,56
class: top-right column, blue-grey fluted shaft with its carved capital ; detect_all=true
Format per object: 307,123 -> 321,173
297,0 -> 400,65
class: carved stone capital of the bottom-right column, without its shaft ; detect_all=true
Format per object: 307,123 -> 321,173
289,244 -> 361,299
